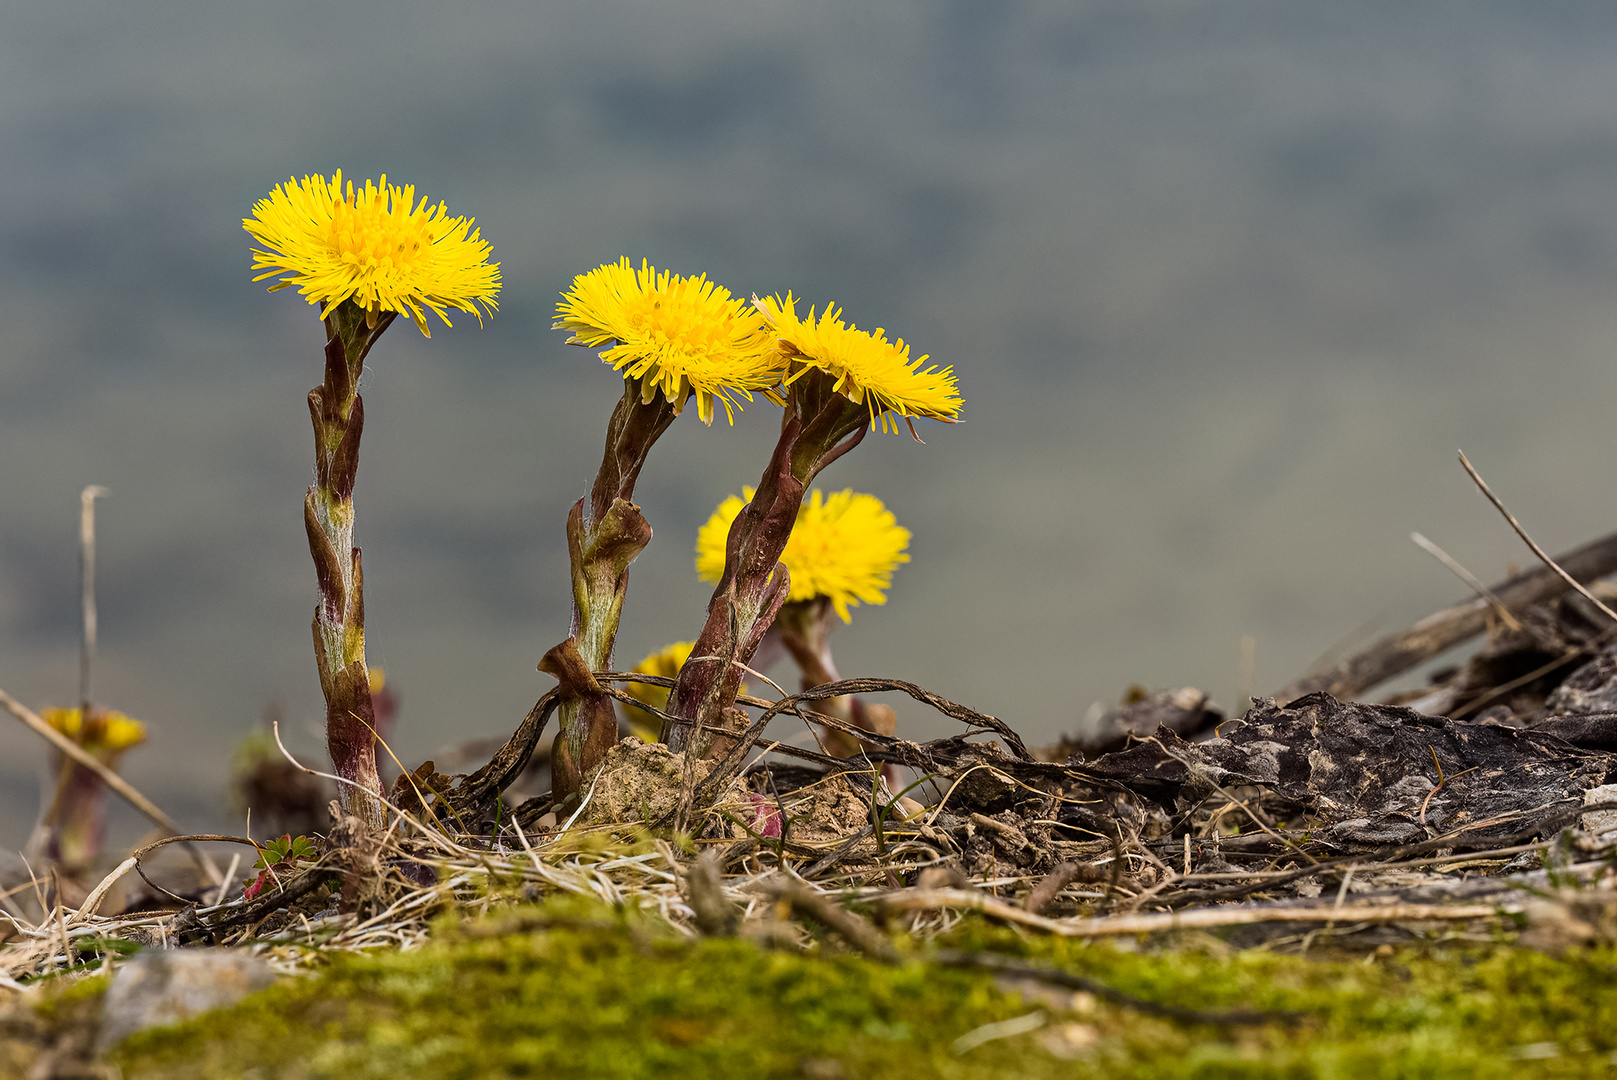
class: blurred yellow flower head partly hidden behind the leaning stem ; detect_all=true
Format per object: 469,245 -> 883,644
697,488 -> 910,622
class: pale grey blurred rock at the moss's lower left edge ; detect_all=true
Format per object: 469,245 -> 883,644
95,949 -> 275,1049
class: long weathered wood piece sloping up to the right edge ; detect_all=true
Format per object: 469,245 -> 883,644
1274,534 -> 1617,703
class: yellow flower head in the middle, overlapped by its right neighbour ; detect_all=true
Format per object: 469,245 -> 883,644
553,259 -> 784,424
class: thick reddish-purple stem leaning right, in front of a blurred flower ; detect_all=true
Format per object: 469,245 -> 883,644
663,370 -> 870,757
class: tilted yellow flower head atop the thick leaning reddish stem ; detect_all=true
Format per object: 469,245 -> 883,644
754,293 -> 960,432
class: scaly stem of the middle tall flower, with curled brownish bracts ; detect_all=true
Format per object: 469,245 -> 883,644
540,378 -> 676,802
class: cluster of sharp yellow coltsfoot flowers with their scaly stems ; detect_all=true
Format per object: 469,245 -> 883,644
245,164 -> 960,792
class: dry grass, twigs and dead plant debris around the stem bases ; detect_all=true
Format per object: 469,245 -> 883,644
9,530 -> 1617,1075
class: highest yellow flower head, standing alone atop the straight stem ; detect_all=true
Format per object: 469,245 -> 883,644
241,170 -> 500,338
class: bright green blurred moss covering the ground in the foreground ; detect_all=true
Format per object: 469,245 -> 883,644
88,902 -> 1617,1080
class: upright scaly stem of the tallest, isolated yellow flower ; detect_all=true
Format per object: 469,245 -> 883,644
304,302 -> 395,828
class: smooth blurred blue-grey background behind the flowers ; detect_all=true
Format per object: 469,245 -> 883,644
0,0 -> 1617,847
